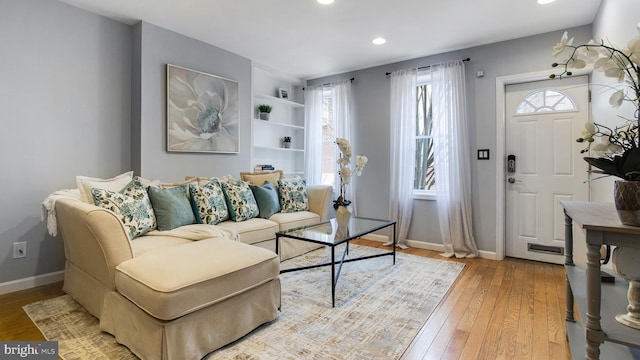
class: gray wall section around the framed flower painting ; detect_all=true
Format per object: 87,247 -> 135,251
133,22 -> 251,181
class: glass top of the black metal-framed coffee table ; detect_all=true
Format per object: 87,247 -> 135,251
277,216 -> 393,245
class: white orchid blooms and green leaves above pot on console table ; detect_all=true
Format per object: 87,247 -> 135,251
550,24 -> 640,181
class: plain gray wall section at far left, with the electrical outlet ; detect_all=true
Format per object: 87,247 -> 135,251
0,0 -> 132,283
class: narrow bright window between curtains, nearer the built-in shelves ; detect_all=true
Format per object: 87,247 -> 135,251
322,88 -> 337,186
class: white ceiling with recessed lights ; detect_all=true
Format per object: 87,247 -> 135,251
60,0 -> 601,78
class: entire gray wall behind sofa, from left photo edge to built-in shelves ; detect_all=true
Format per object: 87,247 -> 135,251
0,0 -> 251,284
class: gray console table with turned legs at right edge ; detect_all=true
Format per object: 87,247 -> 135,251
561,201 -> 640,360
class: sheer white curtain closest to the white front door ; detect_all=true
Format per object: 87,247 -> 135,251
429,60 -> 478,258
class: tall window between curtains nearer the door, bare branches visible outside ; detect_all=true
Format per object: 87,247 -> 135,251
413,76 -> 436,198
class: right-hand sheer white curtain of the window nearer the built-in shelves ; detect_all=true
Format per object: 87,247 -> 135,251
329,80 -> 358,215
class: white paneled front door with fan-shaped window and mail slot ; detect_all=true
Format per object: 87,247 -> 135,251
505,76 -> 589,264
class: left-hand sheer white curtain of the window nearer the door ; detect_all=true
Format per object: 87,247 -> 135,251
387,69 -> 418,248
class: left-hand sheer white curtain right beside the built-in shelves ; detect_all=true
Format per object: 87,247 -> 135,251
304,85 -> 323,184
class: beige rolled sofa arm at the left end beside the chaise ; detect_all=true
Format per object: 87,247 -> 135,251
56,199 -> 133,289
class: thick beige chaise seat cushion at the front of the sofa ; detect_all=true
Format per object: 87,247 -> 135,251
115,239 -> 280,320
